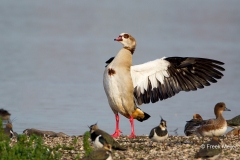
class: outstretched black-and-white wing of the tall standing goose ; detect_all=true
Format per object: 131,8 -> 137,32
131,57 -> 225,105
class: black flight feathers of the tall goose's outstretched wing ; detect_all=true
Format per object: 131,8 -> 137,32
134,57 -> 225,105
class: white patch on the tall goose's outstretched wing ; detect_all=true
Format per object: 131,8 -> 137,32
131,57 -> 170,93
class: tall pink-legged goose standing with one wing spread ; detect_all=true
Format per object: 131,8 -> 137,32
103,33 -> 224,138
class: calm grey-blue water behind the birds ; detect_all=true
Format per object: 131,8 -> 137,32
0,0 -> 240,135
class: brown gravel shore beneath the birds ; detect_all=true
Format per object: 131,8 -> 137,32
43,136 -> 240,160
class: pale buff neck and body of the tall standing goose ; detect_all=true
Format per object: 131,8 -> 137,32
104,48 -> 135,117
